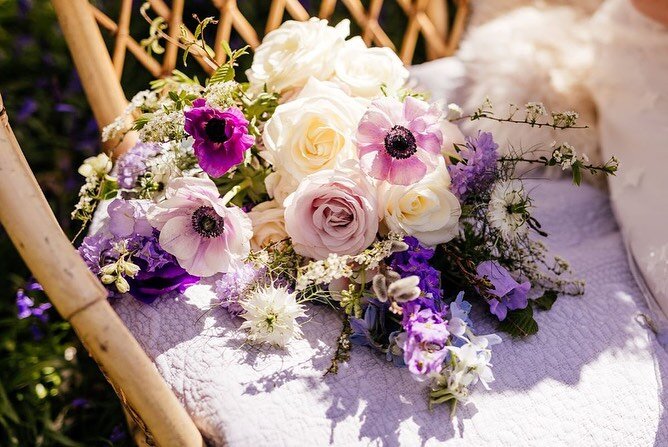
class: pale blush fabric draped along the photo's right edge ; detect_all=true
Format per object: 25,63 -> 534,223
591,0 -> 668,322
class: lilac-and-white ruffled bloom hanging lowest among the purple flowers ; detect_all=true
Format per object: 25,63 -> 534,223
402,309 -> 450,375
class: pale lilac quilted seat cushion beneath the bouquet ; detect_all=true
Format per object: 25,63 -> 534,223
114,181 -> 668,446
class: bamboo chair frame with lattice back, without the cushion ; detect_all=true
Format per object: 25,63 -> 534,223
0,0 -> 468,446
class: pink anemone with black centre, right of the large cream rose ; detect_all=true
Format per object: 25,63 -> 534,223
357,97 -> 443,186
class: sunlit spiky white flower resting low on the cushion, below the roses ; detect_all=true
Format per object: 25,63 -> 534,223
240,285 -> 306,346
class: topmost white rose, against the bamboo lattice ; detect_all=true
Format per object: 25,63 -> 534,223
246,18 -> 350,93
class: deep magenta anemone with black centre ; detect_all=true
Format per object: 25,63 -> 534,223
185,98 -> 255,177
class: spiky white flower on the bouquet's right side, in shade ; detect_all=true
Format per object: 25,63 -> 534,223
487,180 -> 528,241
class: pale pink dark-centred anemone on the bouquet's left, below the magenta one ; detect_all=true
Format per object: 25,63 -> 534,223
148,177 -> 253,277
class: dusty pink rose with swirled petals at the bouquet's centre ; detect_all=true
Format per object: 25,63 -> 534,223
284,168 -> 379,259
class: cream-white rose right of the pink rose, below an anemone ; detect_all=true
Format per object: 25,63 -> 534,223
378,162 -> 462,245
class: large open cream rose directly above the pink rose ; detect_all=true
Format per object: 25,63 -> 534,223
262,78 -> 366,181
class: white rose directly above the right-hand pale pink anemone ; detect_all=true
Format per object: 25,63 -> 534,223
334,36 -> 408,99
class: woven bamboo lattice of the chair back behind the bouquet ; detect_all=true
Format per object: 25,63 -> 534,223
91,0 -> 469,78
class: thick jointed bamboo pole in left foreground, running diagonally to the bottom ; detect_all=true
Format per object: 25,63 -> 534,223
0,93 -> 203,446
